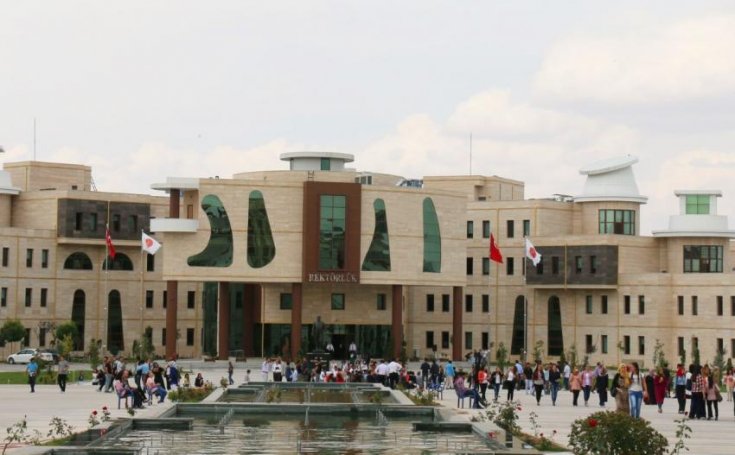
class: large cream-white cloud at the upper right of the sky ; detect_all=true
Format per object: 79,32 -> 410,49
535,15 -> 735,104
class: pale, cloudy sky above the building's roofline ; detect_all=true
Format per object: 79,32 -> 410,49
0,0 -> 735,235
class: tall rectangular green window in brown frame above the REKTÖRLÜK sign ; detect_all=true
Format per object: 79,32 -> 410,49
319,194 -> 347,270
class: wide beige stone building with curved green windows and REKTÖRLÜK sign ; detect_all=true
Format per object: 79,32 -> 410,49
0,152 -> 735,366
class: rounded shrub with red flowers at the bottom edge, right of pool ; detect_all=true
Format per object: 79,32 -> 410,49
569,411 -> 668,455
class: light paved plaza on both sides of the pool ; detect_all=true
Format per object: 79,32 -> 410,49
0,359 -> 735,455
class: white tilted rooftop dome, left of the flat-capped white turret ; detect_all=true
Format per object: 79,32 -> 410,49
574,155 -> 648,204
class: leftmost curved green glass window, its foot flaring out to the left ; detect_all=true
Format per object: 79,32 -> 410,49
186,194 -> 233,267
